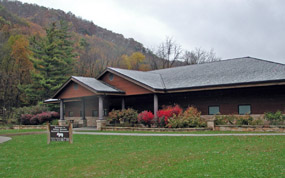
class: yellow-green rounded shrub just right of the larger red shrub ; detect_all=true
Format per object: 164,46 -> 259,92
167,106 -> 206,128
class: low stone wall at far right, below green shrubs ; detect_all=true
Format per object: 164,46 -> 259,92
214,125 -> 285,132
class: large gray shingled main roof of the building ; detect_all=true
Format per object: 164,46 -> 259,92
106,57 -> 285,90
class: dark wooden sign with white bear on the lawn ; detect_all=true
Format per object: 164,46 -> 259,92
47,123 -> 73,144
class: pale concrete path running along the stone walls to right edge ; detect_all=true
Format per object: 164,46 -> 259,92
73,132 -> 285,137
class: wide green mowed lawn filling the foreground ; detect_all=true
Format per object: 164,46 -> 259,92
0,134 -> 285,178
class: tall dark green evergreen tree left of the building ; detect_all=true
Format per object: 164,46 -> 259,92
25,21 -> 75,104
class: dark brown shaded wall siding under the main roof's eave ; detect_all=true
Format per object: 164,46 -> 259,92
117,86 -> 285,115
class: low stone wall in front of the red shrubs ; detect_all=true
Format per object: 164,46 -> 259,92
101,126 -> 209,132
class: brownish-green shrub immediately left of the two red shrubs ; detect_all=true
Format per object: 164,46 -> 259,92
108,108 -> 138,125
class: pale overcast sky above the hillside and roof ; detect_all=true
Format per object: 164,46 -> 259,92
21,0 -> 285,63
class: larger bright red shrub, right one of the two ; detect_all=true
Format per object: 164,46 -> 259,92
157,105 -> 182,127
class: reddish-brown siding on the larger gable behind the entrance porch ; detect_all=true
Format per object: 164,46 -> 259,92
101,72 -> 152,95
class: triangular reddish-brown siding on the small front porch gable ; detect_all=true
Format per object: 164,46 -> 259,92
57,81 -> 95,99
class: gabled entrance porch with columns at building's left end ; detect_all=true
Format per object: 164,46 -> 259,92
46,77 -> 158,127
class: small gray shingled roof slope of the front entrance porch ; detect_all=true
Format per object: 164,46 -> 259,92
72,76 -> 123,93
